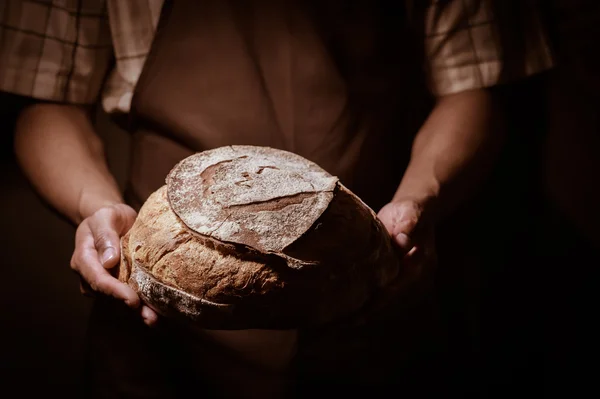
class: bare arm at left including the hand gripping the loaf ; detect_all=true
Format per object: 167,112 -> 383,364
15,104 -> 157,324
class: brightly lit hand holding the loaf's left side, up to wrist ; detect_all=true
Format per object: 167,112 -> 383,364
71,204 -> 157,325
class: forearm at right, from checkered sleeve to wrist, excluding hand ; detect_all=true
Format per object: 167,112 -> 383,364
394,90 -> 504,219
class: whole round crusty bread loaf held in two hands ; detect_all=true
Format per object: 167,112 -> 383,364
119,146 -> 399,330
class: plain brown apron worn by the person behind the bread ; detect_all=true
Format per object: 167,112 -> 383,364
83,0 -> 436,397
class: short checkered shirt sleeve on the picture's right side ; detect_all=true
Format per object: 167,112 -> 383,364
423,0 -> 552,96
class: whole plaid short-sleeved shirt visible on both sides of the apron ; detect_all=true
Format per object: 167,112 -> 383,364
0,0 -> 552,113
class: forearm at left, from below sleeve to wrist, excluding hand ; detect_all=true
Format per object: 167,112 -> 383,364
15,104 -> 122,223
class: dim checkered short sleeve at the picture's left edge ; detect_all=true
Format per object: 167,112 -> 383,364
0,0 -> 113,104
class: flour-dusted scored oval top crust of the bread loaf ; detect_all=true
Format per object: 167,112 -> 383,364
167,145 -> 338,253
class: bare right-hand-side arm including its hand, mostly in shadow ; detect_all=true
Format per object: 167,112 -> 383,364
379,89 -> 504,263
